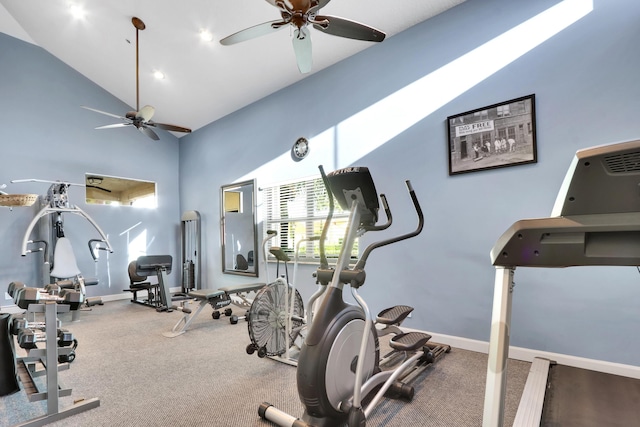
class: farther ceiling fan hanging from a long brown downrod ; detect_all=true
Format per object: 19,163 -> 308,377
82,16 -> 191,141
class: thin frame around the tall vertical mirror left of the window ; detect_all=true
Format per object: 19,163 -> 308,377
220,179 -> 259,277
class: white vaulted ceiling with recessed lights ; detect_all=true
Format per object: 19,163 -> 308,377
0,0 -> 464,134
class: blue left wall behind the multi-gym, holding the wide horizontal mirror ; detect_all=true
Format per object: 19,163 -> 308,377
0,33 -> 180,296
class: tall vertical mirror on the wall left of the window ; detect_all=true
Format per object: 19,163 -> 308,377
220,180 -> 258,277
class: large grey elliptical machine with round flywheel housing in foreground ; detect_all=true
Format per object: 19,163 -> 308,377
258,167 -> 450,427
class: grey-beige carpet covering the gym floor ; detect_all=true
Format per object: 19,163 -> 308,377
0,301 -> 530,427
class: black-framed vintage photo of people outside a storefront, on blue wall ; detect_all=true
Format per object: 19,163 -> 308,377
447,94 -> 538,175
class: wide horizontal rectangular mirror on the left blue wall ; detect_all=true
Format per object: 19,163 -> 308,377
84,173 -> 157,208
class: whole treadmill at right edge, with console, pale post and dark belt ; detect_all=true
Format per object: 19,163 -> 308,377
483,140 -> 640,427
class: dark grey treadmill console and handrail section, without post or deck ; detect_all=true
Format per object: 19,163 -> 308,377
491,140 -> 640,267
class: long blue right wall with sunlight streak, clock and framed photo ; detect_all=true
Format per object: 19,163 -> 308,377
180,0 -> 640,365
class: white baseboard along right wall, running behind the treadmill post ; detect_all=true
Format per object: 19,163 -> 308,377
404,331 -> 640,379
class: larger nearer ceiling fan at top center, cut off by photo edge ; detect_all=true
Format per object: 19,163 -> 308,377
220,0 -> 386,73
